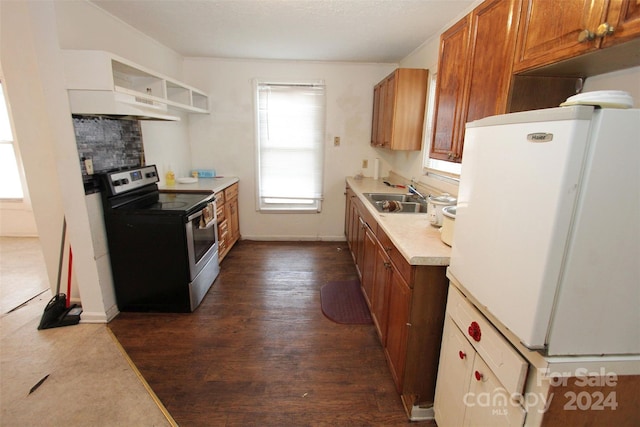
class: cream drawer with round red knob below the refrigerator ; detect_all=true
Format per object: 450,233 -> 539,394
447,285 -> 528,393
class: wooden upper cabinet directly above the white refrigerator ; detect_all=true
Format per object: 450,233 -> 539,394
514,0 -> 640,72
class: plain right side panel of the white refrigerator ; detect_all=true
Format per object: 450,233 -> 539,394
544,109 -> 640,355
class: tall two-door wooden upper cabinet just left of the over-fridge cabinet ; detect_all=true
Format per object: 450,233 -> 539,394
431,0 -> 520,162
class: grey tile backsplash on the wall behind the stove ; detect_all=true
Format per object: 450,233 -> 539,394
73,115 -> 144,194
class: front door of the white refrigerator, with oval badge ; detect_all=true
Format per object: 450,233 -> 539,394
450,107 -> 593,348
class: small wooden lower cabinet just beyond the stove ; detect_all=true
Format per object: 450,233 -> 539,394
216,182 -> 240,261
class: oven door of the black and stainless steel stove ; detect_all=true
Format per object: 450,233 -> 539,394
185,202 -> 218,280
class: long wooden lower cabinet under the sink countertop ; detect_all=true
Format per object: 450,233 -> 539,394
345,183 -> 448,419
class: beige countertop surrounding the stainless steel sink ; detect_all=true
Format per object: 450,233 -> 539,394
347,177 -> 451,265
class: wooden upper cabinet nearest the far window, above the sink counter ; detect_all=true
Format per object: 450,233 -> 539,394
371,68 -> 428,150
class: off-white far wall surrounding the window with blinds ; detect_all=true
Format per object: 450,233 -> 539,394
184,58 -> 396,240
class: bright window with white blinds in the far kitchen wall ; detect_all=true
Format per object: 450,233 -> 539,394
255,81 -> 325,212
